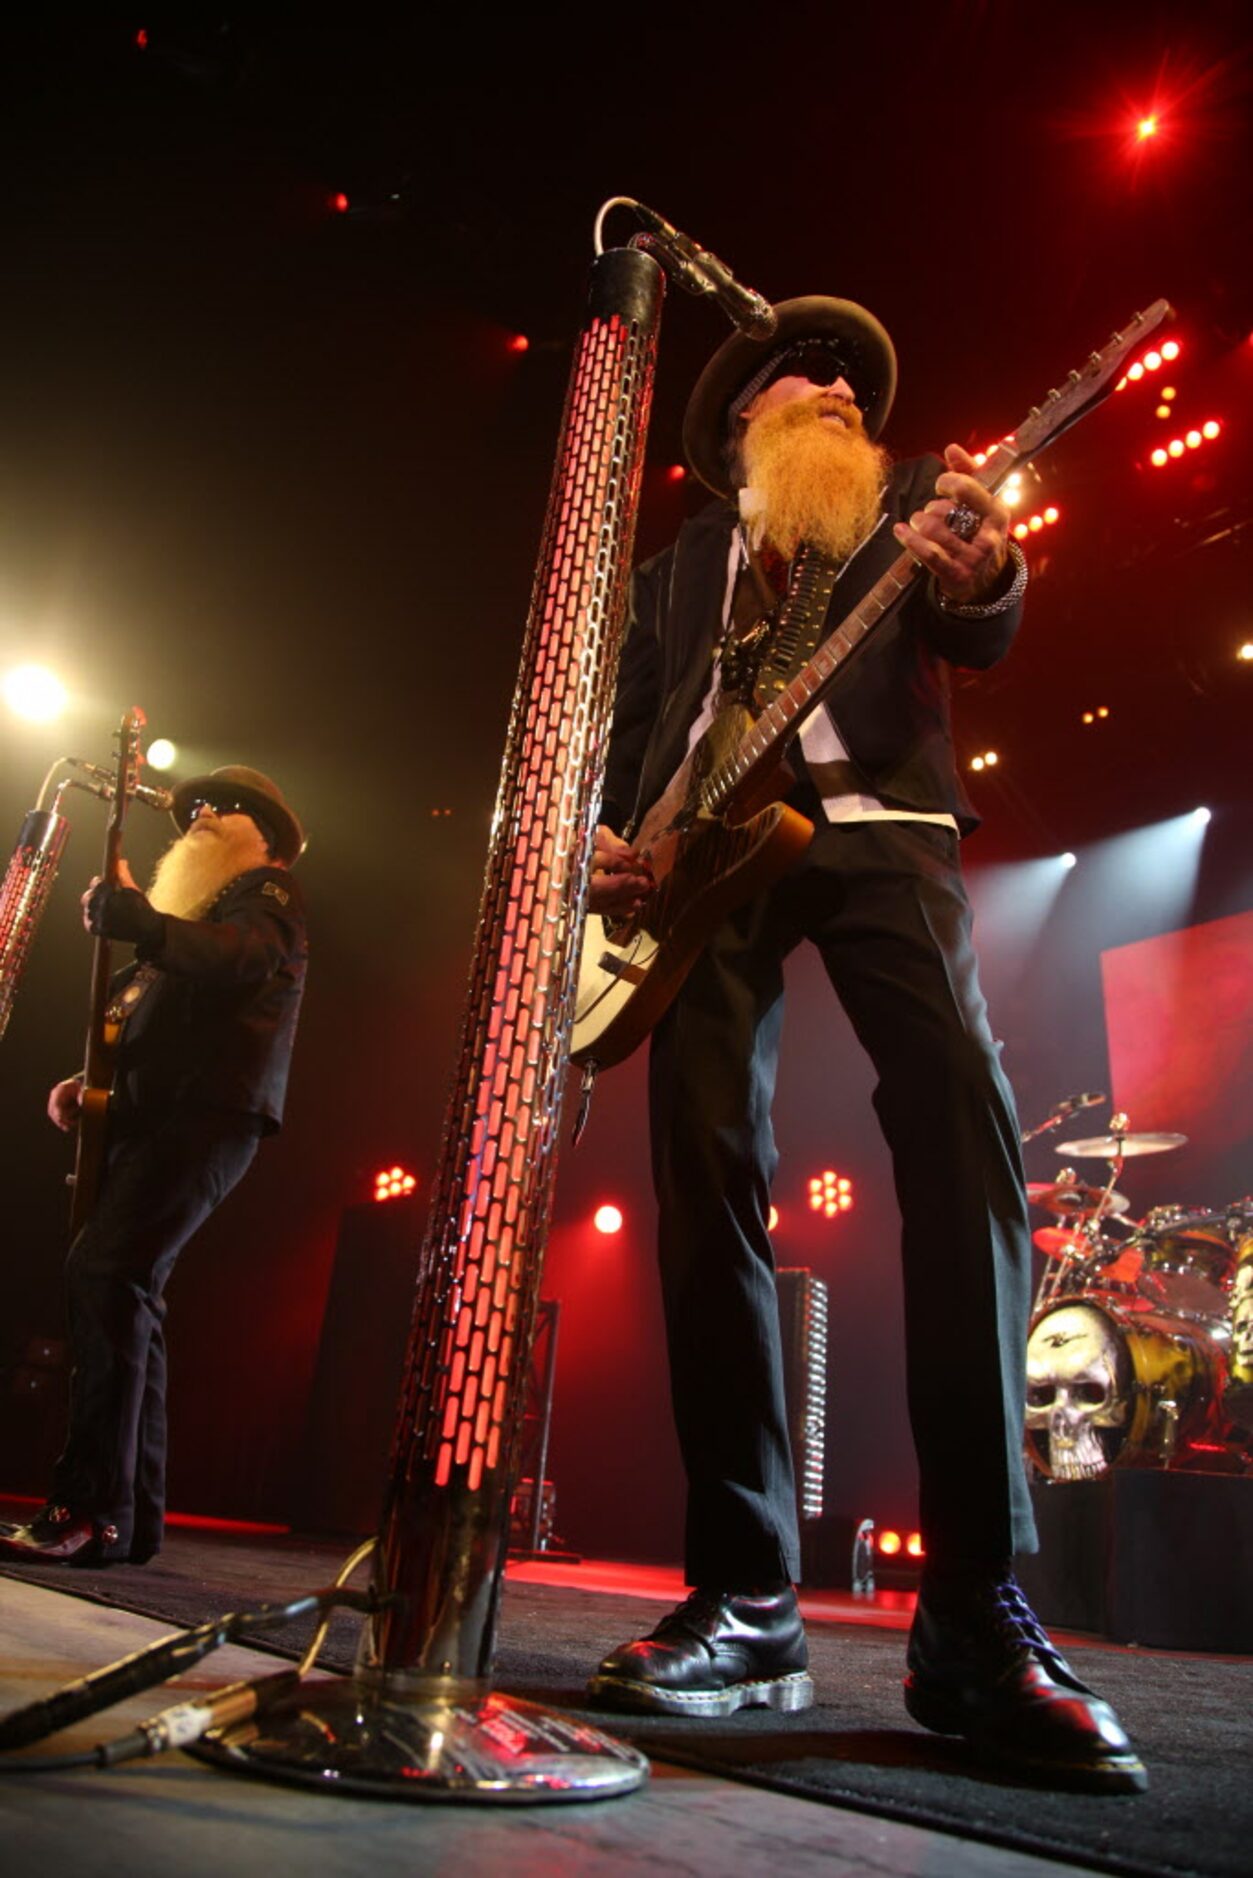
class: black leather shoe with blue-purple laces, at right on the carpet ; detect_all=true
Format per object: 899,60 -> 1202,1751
905,1574 -> 1148,1793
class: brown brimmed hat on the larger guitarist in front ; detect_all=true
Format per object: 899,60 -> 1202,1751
684,293 -> 896,496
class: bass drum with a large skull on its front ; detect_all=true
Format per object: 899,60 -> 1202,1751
1026,1292 -> 1221,1480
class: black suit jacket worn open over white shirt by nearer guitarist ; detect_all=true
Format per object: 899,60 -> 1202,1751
601,456 -> 1022,834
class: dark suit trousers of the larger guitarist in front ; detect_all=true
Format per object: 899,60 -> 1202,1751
650,823 -> 1035,1589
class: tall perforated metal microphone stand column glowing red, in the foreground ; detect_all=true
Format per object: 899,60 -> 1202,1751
376,250 -> 659,1673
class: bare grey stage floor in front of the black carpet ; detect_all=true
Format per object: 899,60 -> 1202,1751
0,1566 -> 1112,1878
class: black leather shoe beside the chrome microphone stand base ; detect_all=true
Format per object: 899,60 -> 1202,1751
588,1585 -> 813,1715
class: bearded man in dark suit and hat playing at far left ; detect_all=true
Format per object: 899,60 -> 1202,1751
0,766 -> 306,1564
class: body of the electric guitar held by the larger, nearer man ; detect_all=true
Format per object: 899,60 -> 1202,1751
571,706 -> 813,1069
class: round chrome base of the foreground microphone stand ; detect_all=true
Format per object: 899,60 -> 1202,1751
188,1681 -> 648,1803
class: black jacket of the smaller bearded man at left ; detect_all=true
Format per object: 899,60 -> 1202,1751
115,868 -> 308,1132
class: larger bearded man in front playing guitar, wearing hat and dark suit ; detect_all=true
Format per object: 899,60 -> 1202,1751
590,297 -> 1146,1792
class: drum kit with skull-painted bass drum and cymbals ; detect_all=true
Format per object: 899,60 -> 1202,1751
1024,1097 -> 1253,1482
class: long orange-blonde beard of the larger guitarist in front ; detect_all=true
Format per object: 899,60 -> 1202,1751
742,398 -> 889,562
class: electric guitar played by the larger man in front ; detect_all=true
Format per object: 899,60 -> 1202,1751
571,300 -> 1174,1069
